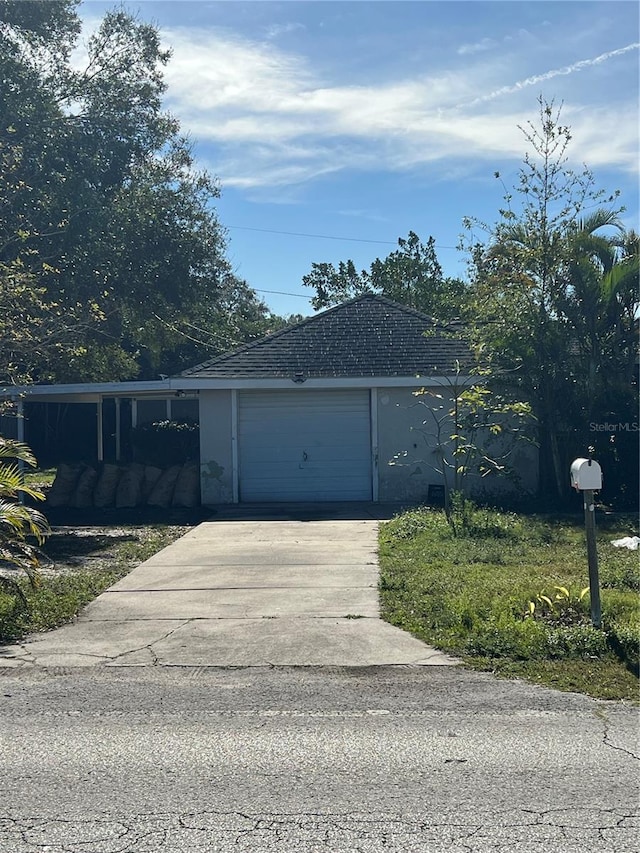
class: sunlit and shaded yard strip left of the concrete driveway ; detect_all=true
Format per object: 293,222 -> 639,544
0,523 -> 190,643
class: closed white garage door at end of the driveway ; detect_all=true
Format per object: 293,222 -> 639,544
238,389 -> 371,501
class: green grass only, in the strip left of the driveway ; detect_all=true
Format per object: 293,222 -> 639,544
0,525 -> 184,643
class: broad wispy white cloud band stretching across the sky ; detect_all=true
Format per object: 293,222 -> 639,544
159,29 -> 638,188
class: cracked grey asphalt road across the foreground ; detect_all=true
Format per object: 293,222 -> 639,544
0,667 -> 640,853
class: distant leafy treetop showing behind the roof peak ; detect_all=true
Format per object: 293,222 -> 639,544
302,231 -> 466,321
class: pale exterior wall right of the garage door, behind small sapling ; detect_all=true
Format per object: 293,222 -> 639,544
377,387 -> 538,503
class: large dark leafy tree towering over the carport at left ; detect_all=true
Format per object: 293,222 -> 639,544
0,0 -> 269,381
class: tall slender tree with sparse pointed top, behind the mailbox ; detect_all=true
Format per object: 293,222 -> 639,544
465,98 -> 634,498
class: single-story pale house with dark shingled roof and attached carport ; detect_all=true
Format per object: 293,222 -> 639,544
0,294 -> 535,505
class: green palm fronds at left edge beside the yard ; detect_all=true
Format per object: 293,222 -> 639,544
0,437 -> 51,602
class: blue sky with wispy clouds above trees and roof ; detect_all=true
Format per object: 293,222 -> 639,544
80,0 -> 640,314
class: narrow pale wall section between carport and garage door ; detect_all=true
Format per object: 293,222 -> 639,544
200,390 -> 233,504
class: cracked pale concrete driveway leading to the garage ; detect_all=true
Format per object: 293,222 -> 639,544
0,510 -> 455,667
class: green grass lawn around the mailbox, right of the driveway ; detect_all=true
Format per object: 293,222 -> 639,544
380,508 -> 640,701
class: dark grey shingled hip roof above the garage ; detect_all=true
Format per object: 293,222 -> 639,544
181,294 -> 469,379
